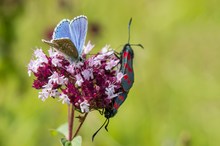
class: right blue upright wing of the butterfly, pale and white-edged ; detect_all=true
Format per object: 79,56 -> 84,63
70,15 -> 88,56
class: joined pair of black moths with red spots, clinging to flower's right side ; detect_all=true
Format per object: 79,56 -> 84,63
92,18 -> 143,140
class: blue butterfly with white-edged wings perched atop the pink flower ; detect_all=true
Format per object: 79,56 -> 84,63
42,15 -> 88,61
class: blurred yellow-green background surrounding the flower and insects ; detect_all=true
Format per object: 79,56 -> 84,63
0,0 -> 220,146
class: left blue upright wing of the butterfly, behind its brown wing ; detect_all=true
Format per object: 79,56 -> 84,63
52,19 -> 71,40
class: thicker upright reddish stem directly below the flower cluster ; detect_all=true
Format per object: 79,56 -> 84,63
68,104 -> 75,141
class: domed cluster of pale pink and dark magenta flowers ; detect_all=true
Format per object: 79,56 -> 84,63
28,42 -> 123,113
